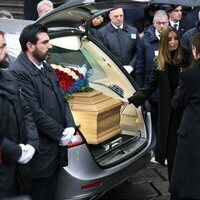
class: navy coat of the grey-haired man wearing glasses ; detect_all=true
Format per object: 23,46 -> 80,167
134,26 -> 159,101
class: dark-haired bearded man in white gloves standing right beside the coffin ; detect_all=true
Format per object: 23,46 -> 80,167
9,24 -> 75,200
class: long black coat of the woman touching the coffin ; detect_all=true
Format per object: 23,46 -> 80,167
128,63 -> 182,165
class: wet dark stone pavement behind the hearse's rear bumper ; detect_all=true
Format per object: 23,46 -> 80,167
100,159 -> 170,200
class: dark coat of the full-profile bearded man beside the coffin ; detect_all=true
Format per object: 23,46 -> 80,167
9,52 -> 75,178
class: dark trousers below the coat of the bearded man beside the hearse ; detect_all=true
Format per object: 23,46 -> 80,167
32,171 -> 59,200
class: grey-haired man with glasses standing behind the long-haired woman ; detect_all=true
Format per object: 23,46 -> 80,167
134,10 -> 169,138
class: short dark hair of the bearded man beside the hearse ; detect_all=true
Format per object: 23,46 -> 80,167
19,24 -> 48,51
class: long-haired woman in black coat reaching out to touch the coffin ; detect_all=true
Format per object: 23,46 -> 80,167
121,27 -> 182,178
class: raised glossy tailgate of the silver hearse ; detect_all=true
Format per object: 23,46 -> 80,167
36,0 -> 149,28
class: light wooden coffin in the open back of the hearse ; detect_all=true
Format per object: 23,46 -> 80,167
69,91 -> 122,144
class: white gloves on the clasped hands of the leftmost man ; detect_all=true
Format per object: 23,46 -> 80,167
18,144 -> 35,164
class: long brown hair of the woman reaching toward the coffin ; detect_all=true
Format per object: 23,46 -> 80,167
156,26 -> 183,71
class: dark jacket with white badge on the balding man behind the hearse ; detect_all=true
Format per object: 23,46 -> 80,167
98,23 -> 140,66
